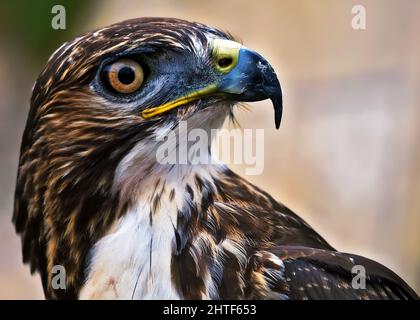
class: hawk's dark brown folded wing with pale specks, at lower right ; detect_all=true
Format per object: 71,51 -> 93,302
248,246 -> 419,300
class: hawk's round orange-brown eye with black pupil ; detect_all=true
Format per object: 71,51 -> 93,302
102,59 -> 144,94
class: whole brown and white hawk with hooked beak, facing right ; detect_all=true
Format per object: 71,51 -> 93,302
13,18 -> 418,299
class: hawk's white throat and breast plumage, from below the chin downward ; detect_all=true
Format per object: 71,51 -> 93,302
80,112 -> 230,299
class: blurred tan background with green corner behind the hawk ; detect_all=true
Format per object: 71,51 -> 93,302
0,0 -> 420,299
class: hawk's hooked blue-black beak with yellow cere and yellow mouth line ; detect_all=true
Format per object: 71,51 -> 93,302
141,39 -> 283,129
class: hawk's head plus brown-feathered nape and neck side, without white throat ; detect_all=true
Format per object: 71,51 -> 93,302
14,18 -> 282,298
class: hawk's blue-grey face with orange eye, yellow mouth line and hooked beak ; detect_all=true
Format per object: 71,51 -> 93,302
90,21 -> 282,128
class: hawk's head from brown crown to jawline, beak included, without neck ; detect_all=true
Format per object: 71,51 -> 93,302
32,18 -> 282,156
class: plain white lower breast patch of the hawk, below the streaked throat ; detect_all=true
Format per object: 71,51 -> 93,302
80,198 -> 180,299
